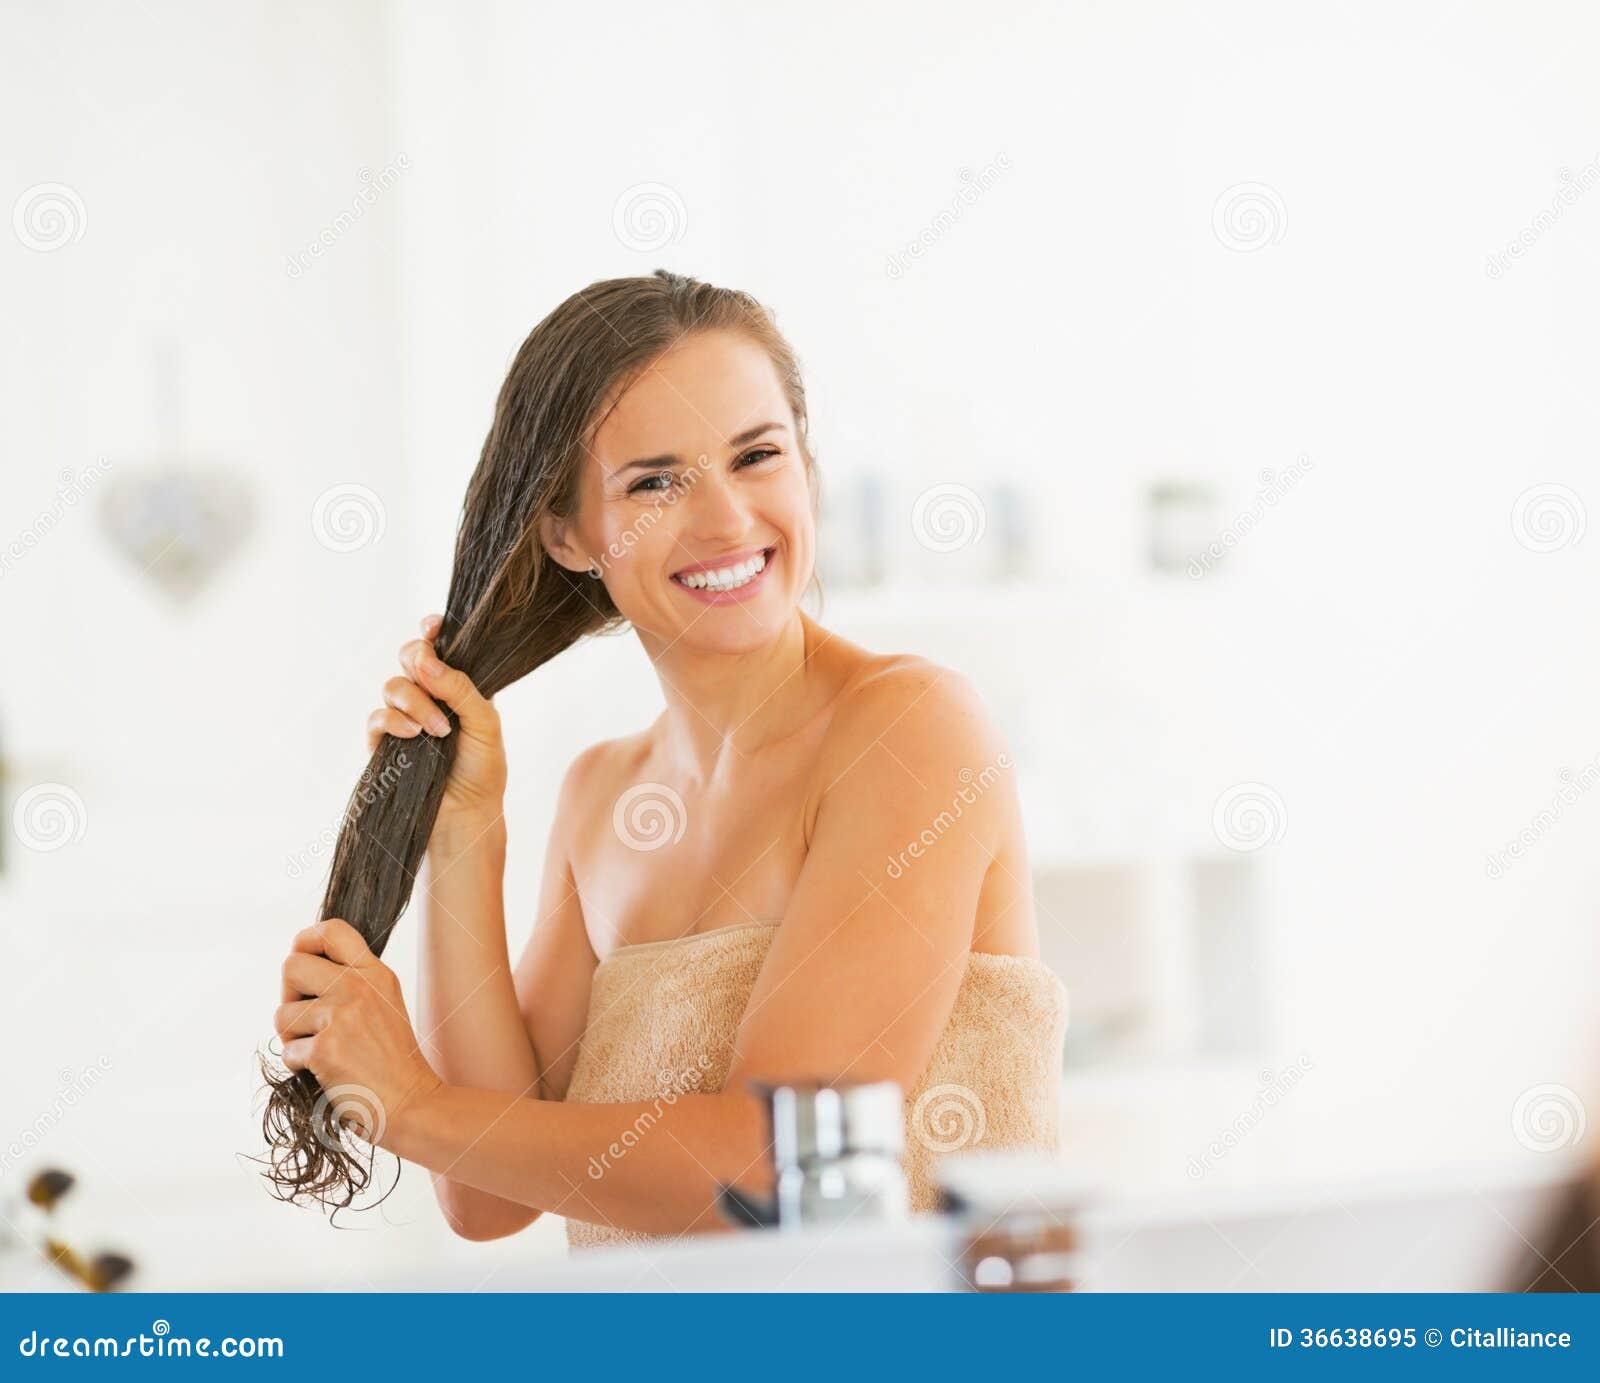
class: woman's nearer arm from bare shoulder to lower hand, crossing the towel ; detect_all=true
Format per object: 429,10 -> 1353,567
285,663 -> 1016,1234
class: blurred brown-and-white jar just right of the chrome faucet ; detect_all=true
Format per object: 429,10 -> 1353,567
936,1153 -> 1093,1292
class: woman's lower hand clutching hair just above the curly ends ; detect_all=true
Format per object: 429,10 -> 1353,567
274,917 -> 443,1146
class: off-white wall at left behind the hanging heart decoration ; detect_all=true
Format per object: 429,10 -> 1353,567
0,3 -> 531,1285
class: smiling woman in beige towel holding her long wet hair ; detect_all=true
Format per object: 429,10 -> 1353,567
275,271 -> 1066,1245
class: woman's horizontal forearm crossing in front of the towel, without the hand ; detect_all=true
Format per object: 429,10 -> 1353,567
382,1082 -> 770,1234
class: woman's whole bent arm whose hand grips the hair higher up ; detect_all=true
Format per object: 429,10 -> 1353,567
368,618 -> 595,1239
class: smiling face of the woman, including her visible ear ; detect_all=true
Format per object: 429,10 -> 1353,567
546,330 -> 816,653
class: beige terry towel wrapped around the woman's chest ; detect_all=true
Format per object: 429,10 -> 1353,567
566,922 -> 1067,1249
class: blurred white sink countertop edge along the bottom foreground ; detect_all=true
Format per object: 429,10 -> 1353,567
374,1159 -> 1576,1292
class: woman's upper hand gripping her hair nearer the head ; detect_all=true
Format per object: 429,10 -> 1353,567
366,615 -> 506,829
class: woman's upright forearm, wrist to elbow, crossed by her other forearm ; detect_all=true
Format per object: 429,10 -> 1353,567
416,820 -> 539,1239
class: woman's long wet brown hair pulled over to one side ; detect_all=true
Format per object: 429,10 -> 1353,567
261,269 -> 818,1209
